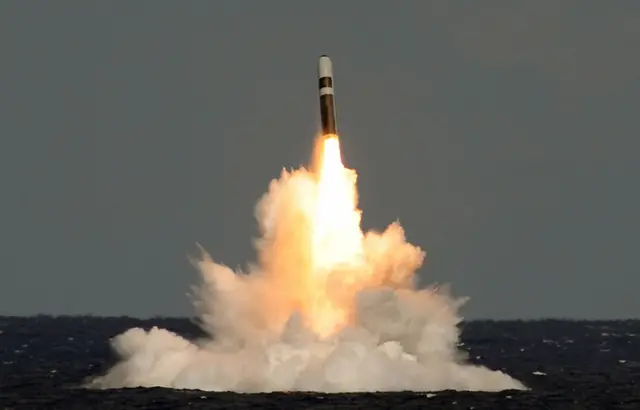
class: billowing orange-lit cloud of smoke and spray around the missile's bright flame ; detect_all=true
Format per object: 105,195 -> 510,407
89,169 -> 525,392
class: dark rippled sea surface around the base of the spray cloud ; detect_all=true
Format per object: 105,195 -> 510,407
0,316 -> 640,410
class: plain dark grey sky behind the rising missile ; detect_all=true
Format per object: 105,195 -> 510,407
0,0 -> 640,318
